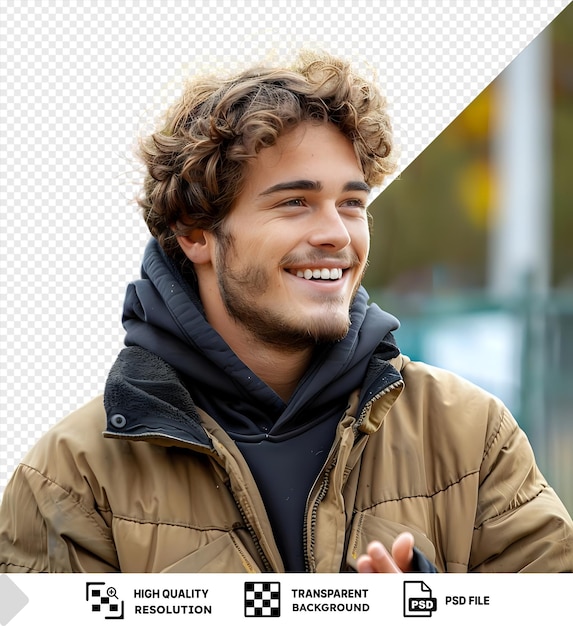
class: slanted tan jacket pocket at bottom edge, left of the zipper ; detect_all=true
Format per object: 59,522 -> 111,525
163,532 -> 261,574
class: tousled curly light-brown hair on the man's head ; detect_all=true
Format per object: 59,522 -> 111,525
137,51 -> 396,262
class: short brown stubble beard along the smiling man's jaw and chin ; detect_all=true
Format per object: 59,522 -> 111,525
212,234 -> 358,352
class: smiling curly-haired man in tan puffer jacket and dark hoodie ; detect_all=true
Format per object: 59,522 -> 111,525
0,55 -> 573,572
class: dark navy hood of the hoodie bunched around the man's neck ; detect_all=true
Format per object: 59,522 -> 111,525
123,239 -> 399,441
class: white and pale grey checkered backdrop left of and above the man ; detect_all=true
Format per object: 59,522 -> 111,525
0,0 -> 568,494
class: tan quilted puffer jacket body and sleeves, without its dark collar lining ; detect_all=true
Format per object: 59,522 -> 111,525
0,356 -> 573,572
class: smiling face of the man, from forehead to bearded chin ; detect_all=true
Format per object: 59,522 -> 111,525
199,123 -> 369,350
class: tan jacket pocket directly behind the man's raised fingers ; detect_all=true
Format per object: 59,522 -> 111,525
346,513 -> 436,570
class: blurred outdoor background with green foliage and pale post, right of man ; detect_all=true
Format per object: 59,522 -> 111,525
365,4 -> 573,513
